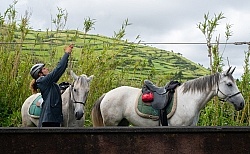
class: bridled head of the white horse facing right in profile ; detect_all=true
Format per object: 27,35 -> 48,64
217,67 -> 245,111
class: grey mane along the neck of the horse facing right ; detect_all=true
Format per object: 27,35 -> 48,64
183,73 -> 220,93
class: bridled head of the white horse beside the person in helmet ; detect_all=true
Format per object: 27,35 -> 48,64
69,71 -> 93,120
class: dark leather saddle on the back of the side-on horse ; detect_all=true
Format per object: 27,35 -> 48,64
142,80 -> 181,126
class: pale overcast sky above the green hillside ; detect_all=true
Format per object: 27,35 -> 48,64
0,0 -> 250,78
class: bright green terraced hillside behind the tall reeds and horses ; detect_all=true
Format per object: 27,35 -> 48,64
19,30 -> 209,80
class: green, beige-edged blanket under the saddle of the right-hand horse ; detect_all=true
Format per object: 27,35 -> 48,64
136,93 -> 176,120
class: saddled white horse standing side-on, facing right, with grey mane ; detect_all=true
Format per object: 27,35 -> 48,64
91,67 -> 245,127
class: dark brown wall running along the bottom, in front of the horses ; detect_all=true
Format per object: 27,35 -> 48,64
0,127 -> 250,154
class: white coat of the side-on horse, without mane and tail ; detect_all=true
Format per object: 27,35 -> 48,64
95,67 -> 244,127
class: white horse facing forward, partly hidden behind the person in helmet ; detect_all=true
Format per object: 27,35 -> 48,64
21,71 -> 93,127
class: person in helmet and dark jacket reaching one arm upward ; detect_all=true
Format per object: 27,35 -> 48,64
30,44 -> 73,127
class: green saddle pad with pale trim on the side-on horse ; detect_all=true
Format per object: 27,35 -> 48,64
136,94 -> 174,120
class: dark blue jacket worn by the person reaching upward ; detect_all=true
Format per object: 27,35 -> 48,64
36,53 -> 69,127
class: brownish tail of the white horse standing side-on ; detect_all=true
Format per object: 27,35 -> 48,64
91,94 -> 105,127
